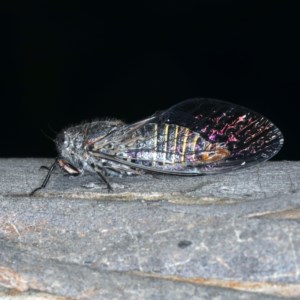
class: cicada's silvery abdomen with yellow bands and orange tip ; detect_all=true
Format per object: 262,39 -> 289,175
122,123 -> 229,170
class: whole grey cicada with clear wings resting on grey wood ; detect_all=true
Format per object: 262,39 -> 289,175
31,98 -> 284,195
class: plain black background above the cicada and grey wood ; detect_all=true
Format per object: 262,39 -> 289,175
0,0 -> 300,160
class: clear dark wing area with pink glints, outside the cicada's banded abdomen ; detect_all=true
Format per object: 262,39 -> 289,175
152,98 -> 284,173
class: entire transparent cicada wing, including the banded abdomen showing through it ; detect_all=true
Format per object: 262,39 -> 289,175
89,98 -> 283,175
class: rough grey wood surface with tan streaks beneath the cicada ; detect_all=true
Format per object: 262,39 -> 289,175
0,159 -> 300,299
